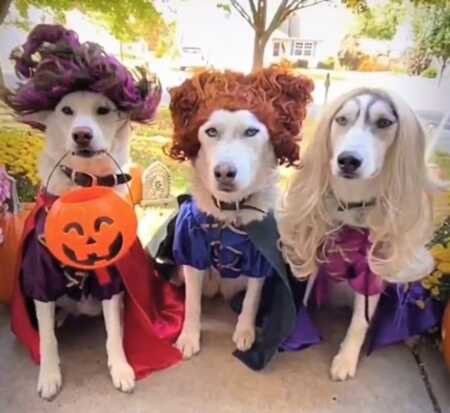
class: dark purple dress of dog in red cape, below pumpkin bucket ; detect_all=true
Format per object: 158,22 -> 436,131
20,196 -> 124,302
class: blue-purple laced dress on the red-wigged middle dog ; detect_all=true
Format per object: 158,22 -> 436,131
173,200 -> 276,278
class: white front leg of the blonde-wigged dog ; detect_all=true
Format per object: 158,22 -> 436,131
331,293 -> 380,381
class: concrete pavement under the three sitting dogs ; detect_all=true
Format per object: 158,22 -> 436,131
0,299 -> 450,413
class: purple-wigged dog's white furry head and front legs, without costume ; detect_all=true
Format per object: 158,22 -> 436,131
27,92 -> 134,399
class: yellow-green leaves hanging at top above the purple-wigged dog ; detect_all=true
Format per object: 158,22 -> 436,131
10,0 -> 173,54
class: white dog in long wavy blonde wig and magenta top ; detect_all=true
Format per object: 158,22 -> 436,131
279,88 -> 442,380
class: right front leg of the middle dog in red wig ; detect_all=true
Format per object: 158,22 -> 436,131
233,277 -> 264,351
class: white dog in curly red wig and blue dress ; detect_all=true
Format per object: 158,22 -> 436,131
156,67 -> 313,370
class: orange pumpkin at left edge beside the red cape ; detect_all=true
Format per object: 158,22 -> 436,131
0,208 -> 31,304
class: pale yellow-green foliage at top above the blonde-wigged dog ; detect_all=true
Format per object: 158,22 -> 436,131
354,1 -> 406,40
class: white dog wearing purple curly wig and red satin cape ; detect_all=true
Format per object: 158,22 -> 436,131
3,25 -> 183,399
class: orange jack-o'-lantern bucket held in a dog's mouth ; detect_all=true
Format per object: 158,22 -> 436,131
45,186 -> 137,270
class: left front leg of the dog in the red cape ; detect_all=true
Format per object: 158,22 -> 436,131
34,300 -> 62,400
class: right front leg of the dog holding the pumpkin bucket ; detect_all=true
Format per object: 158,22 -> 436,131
102,293 -> 135,393
